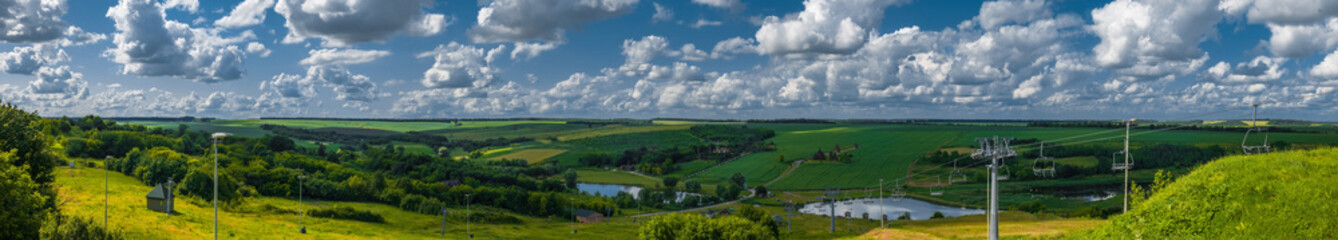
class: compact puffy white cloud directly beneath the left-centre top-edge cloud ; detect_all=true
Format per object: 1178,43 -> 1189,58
417,42 -> 498,88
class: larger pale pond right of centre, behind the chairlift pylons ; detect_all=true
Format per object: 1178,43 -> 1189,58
799,198 -> 985,220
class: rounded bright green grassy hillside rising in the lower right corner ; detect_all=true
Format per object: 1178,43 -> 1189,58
1072,149 -> 1338,239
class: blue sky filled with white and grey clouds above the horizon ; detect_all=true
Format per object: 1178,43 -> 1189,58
0,0 -> 1338,121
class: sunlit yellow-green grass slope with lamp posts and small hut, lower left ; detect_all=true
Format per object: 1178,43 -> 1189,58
55,164 -> 652,239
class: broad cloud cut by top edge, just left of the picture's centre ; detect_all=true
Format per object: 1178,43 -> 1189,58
468,0 -> 638,43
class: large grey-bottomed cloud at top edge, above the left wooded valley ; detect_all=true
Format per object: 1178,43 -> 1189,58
274,0 -> 451,46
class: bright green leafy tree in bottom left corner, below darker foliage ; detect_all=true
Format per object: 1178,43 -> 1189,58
0,150 -> 48,239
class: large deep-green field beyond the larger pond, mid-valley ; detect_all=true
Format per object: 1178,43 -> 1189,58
701,125 -> 958,190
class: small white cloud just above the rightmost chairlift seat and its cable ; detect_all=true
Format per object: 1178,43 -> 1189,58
1204,56 -> 1287,84
